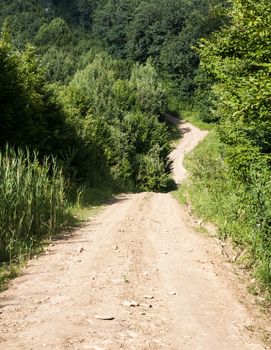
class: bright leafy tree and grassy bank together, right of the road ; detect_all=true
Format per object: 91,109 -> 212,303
181,0 -> 271,297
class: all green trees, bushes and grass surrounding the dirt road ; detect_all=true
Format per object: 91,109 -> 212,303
0,0 -> 271,288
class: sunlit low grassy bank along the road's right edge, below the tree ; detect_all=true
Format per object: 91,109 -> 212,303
176,129 -> 271,308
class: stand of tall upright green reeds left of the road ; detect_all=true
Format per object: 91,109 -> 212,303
0,147 -> 67,263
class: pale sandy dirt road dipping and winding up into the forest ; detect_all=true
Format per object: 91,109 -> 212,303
0,119 -> 270,350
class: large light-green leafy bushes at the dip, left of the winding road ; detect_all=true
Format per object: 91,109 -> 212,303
60,54 -> 170,190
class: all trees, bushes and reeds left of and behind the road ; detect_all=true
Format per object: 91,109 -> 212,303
0,0 -> 225,280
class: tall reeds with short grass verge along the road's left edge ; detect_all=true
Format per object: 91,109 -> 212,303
0,147 -> 112,290
